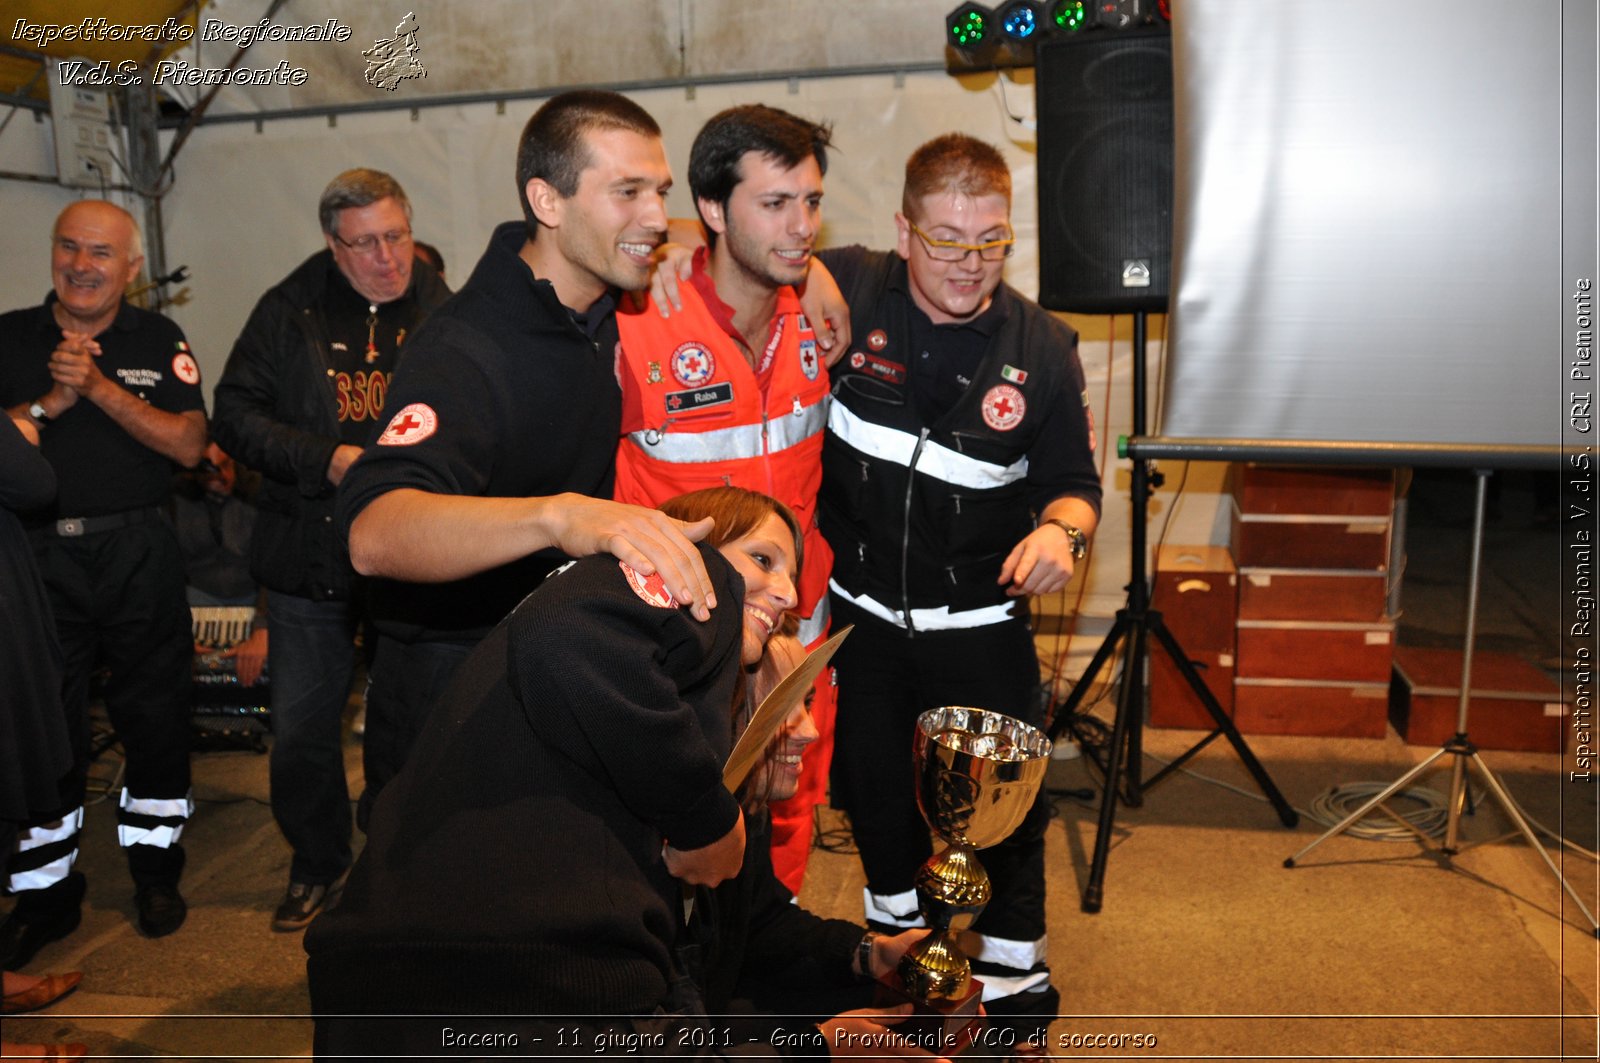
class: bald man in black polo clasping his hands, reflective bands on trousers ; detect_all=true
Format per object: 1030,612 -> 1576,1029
0,200 -> 206,967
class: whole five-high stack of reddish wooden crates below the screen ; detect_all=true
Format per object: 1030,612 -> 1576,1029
1232,463 -> 1395,738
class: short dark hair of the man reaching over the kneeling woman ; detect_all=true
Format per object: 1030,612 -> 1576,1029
517,88 -> 661,240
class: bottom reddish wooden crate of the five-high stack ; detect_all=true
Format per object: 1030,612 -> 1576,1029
1234,679 -> 1389,738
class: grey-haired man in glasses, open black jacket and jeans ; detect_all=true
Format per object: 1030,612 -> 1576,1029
216,170 -> 450,930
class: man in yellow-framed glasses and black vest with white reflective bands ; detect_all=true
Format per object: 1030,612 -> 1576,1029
816,133 -> 1101,1037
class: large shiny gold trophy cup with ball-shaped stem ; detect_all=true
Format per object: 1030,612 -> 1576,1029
898,706 -> 1051,1050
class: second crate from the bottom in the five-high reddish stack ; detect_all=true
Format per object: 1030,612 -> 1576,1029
1235,620 -> 1395,687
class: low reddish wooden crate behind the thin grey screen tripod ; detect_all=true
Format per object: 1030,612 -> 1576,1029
1389,647 -> 1568,752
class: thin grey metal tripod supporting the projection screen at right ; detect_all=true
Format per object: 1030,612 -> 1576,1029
1283,469 -> 1600,938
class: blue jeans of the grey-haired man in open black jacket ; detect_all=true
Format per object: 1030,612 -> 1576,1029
267,591 -> 355,885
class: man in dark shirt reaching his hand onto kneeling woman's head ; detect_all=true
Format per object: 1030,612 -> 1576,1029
338,91 -> 715,821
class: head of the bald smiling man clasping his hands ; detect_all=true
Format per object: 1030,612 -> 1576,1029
50,200 -> 144,336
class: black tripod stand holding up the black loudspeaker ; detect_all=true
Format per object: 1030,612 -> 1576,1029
1050,311 -> 1299,913
